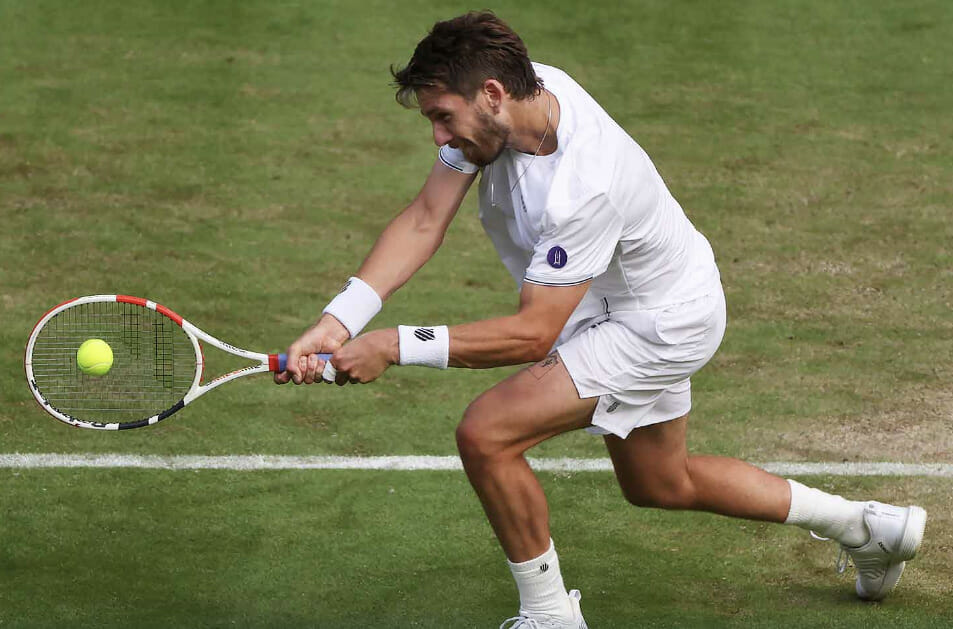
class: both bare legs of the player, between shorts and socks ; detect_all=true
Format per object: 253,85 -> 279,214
457,355 -> 791,562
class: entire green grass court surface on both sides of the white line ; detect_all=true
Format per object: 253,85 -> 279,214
0,0 -> 953,628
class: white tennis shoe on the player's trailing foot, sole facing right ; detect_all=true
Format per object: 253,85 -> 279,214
837,501 -> 927,601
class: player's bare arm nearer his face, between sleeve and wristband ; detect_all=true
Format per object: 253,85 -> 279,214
357,160 -> 476,299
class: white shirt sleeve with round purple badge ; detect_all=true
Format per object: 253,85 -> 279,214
523,193 -> 623,286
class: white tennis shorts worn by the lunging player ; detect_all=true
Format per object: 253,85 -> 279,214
556,287 -> 726,439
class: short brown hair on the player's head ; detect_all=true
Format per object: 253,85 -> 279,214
390,11 -> 543,107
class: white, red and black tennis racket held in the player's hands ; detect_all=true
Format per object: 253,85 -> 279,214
24,295 -> 331,430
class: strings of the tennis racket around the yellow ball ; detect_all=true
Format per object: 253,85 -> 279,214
32,302 -> 197,422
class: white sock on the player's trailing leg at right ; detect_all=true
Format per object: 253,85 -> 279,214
784,479 -> 870,546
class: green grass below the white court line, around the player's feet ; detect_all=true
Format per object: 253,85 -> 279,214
0,470 -> 953,628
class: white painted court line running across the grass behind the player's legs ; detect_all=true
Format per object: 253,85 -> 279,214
0,453 -> 953,478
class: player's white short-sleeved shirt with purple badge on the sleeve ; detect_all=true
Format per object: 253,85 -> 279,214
439,63 -> 720,339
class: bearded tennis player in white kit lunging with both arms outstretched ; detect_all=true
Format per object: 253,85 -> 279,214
276,12 -> 926,629
